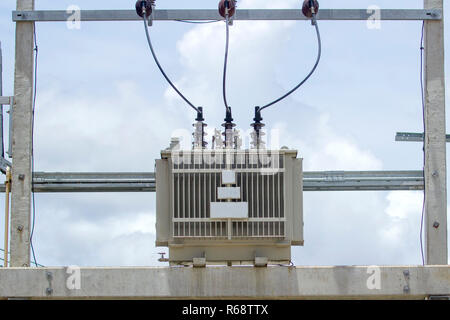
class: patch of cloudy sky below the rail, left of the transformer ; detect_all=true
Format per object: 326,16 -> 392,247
34,194 -> 164,266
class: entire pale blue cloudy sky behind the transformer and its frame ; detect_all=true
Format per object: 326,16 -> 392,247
0,0 -> 450,266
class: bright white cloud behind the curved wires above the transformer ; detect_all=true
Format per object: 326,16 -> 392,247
165,3 -> 295,126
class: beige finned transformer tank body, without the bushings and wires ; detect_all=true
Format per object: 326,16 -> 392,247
156,143 -> 303,265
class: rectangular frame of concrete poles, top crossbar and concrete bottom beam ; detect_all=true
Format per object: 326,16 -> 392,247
6,0 -> 450,298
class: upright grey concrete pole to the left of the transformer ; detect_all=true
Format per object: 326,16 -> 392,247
10,0 -> 34,267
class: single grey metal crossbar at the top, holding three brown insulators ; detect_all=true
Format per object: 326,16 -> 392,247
12,9 -> 442,22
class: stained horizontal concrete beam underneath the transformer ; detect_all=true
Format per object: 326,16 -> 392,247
0,266 -> 450,299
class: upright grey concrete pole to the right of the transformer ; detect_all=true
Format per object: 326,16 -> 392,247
424,0 -> 448,265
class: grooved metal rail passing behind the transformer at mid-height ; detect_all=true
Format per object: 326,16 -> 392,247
0,171 -> 424,193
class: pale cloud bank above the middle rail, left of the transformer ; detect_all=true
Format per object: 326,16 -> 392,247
35,81 -> 184,171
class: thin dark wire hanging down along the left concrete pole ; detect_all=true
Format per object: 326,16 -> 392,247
30,24 -> 39,266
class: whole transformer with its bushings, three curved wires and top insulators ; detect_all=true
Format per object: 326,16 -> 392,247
136,0 -> 322,267
